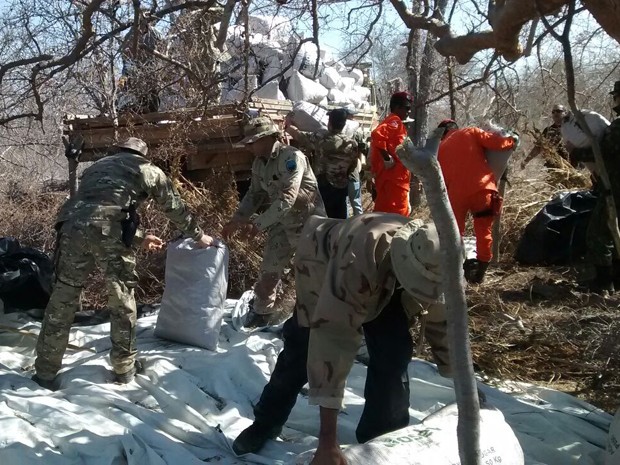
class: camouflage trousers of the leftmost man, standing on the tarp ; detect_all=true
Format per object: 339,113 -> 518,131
35,222 -> 137,380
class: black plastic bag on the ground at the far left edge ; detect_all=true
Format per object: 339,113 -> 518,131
0,237 -> 54,313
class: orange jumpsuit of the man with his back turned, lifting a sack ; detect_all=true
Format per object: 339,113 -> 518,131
439,128 -> 514,262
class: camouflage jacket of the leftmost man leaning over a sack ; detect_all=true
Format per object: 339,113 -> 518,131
57,152 -> 203,240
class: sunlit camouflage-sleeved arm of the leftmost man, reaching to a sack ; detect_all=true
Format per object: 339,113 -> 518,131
142,163 -> 203,241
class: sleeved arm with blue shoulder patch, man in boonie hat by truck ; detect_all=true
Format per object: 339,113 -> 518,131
254,149 -> 308,231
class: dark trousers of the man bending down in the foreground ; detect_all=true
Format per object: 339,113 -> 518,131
254,292 -> 413,442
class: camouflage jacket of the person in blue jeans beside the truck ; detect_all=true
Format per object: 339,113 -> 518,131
298,131 -> 359,188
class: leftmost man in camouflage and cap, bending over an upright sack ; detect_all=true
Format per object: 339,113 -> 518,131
33,137 -> 213,389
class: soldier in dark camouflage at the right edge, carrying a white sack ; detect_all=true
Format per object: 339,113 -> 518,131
570,81 -> 620,293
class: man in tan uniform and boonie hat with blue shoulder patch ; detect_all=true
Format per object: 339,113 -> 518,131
222,117 -> 325,328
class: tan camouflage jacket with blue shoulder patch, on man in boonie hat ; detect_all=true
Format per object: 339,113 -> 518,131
233,142 -> 324,230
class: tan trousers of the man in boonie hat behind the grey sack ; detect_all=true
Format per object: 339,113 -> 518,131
254,225 -> 303,315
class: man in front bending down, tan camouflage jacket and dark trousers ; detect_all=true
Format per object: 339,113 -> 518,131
233,213 -> 450,464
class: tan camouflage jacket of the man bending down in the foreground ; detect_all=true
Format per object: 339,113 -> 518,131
295,213 -> 445,409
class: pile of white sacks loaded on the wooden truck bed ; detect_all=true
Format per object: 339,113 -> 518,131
221,16 -> 370,111
